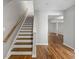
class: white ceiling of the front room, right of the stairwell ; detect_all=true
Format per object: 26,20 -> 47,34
34,0 -> 75,11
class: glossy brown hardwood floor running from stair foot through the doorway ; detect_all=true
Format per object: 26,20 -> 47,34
10,35 -> 75,59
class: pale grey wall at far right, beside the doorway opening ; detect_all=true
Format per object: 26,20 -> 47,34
63,6 -> 75,48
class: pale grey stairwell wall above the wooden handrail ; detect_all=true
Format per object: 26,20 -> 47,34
3,1 -> 26,38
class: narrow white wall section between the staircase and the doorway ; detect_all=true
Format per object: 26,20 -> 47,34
35,12 -> 48,45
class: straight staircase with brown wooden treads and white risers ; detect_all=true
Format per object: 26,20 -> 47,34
7,17 -> 33,59
